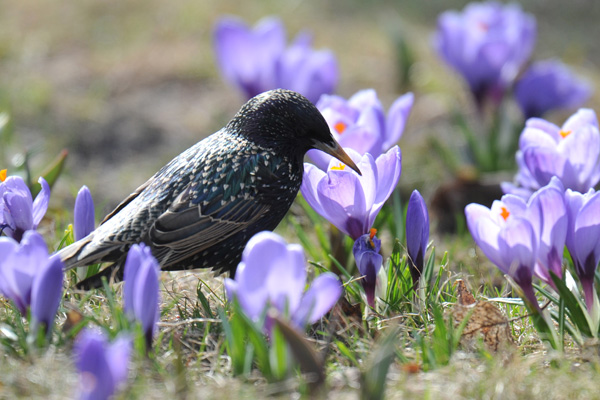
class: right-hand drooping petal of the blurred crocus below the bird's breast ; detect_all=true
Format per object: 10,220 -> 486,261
294,272 -> 343,327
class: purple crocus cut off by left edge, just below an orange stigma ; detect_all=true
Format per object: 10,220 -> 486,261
0,176 -> 50,242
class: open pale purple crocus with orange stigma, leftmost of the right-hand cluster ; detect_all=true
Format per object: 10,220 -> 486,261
465,195 -> 540,310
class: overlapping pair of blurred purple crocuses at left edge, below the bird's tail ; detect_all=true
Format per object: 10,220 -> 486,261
0,231 -> 63,327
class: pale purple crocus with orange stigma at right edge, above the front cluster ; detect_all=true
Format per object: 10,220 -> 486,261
502,109 -> 600,198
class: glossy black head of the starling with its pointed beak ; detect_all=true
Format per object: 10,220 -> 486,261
227,89 -> 360,175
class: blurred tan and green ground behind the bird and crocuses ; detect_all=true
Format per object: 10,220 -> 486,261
0,0 -> 600,215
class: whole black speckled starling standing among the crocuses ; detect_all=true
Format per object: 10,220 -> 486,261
59,89 -> 360,288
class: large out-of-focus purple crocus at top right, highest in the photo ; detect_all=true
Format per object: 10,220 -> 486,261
434,1 -> 536,106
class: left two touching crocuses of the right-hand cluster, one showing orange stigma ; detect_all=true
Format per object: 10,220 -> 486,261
465,178 -> 567,311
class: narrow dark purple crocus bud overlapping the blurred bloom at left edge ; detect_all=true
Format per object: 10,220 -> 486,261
31,256 -> 64,333
